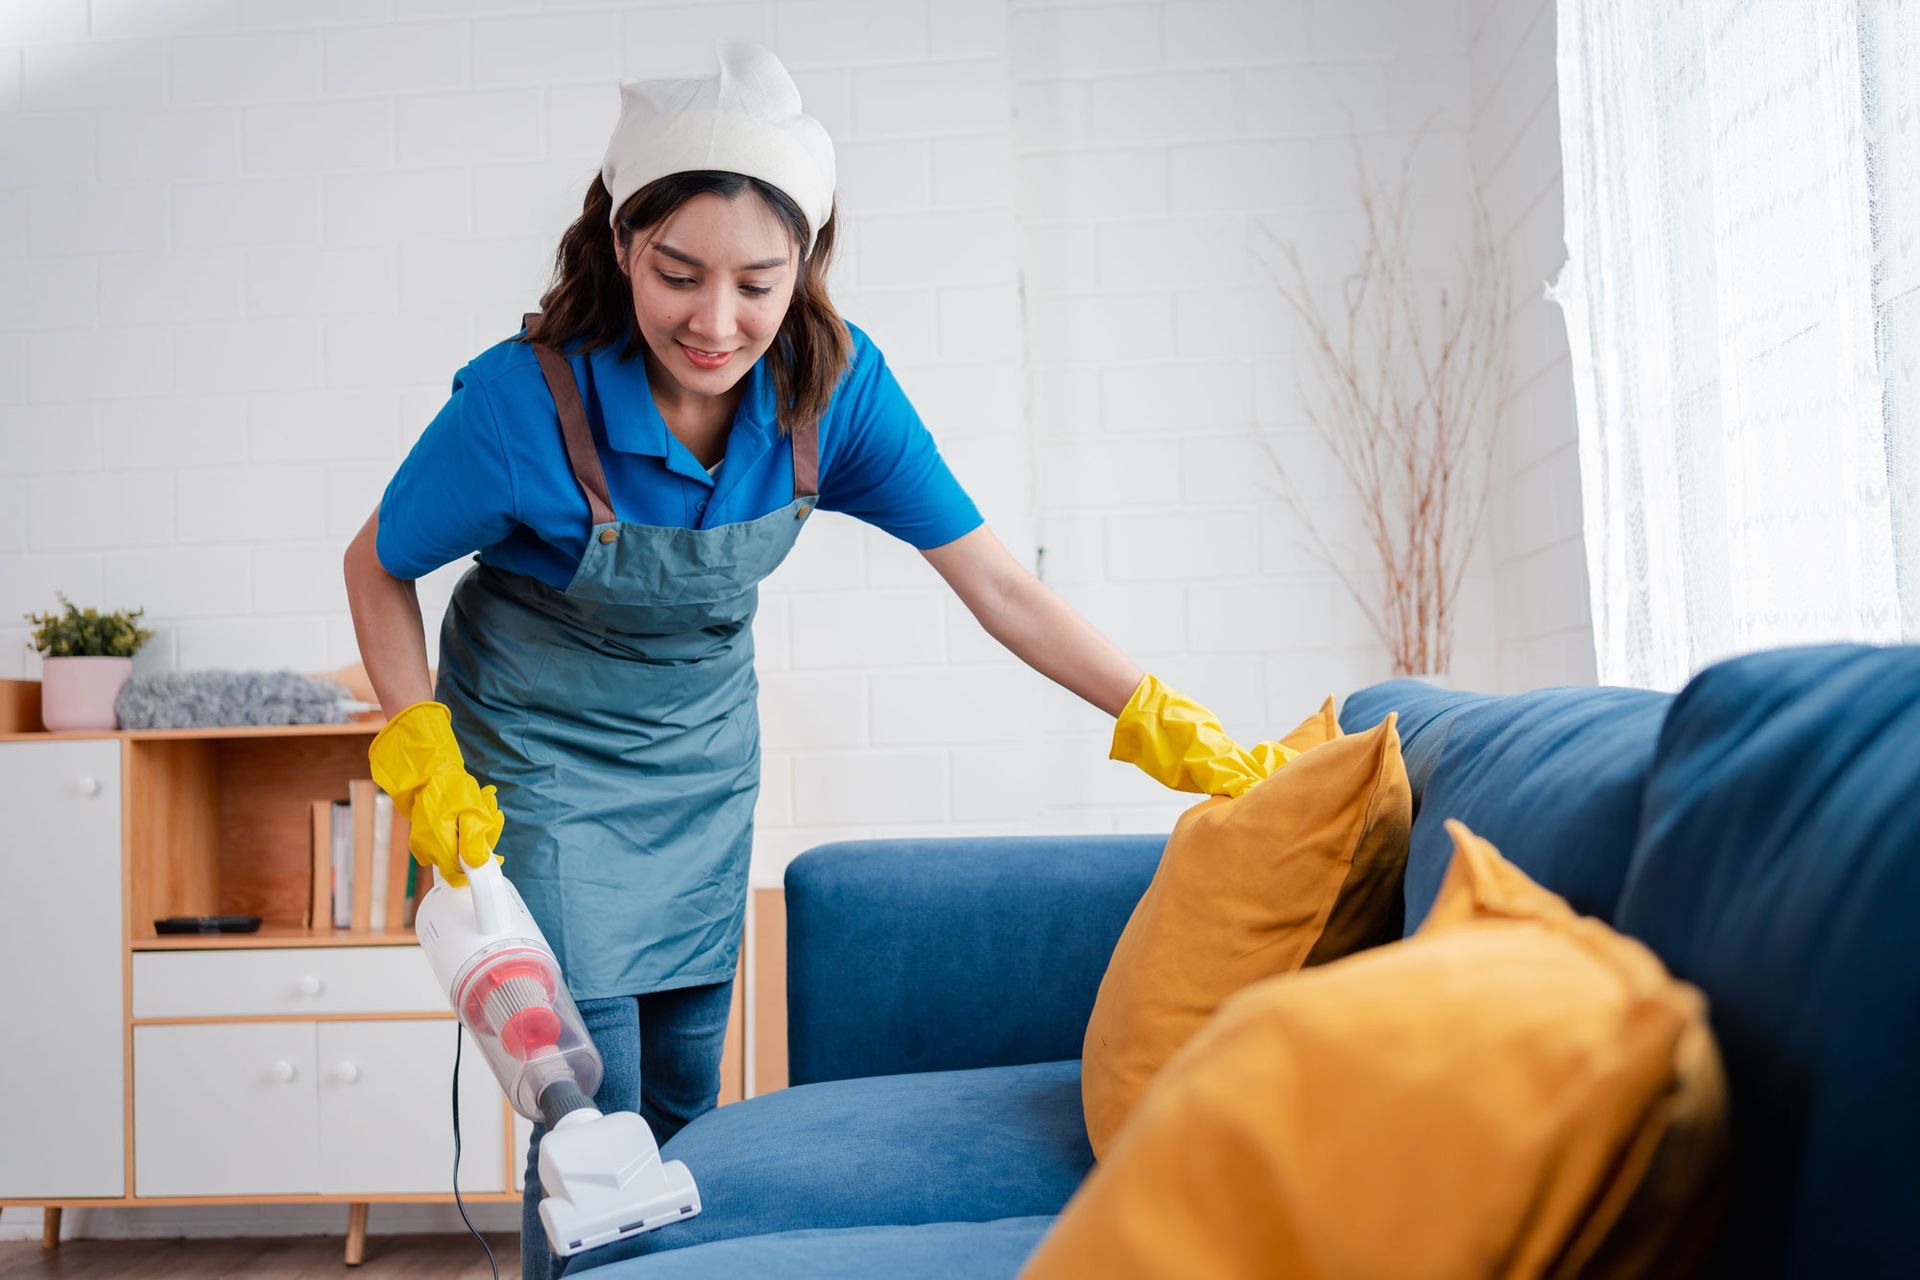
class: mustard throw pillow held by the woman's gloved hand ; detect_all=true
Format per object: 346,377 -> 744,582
1081,699 -> 1413,1155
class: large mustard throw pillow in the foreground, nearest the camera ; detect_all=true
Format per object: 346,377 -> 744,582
1021,821 -> 1726,1280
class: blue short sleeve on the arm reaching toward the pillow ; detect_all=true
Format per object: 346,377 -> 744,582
820,330 -> 981,551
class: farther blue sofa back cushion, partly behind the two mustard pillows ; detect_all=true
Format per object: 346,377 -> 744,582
1340,679 -> 1672,933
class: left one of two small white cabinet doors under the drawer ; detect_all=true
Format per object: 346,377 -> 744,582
132,1023 -> 319,1196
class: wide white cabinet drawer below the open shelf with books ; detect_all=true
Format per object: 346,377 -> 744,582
132,946 -> 447,1017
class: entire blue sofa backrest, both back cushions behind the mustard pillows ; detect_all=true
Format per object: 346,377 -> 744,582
1340,645 -> 1920,1276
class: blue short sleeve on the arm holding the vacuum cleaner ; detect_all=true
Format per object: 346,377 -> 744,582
374,370 -> 518,580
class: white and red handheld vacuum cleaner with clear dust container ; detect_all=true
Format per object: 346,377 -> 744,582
413,858 -> 701,1257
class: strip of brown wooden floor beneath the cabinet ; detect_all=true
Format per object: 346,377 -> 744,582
0,1234 -> 520,1280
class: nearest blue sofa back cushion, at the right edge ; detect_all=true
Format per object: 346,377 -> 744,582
1619,645 -> 1920,1276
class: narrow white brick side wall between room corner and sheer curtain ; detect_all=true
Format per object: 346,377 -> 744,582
1469,0 -> 1594,689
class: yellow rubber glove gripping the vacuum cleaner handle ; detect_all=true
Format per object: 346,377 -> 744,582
367,702 -> 507,885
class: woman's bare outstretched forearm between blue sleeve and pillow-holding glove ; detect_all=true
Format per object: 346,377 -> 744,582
922,524 -> 1144,716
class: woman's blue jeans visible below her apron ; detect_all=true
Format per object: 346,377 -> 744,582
520,983 -> 733,1280
